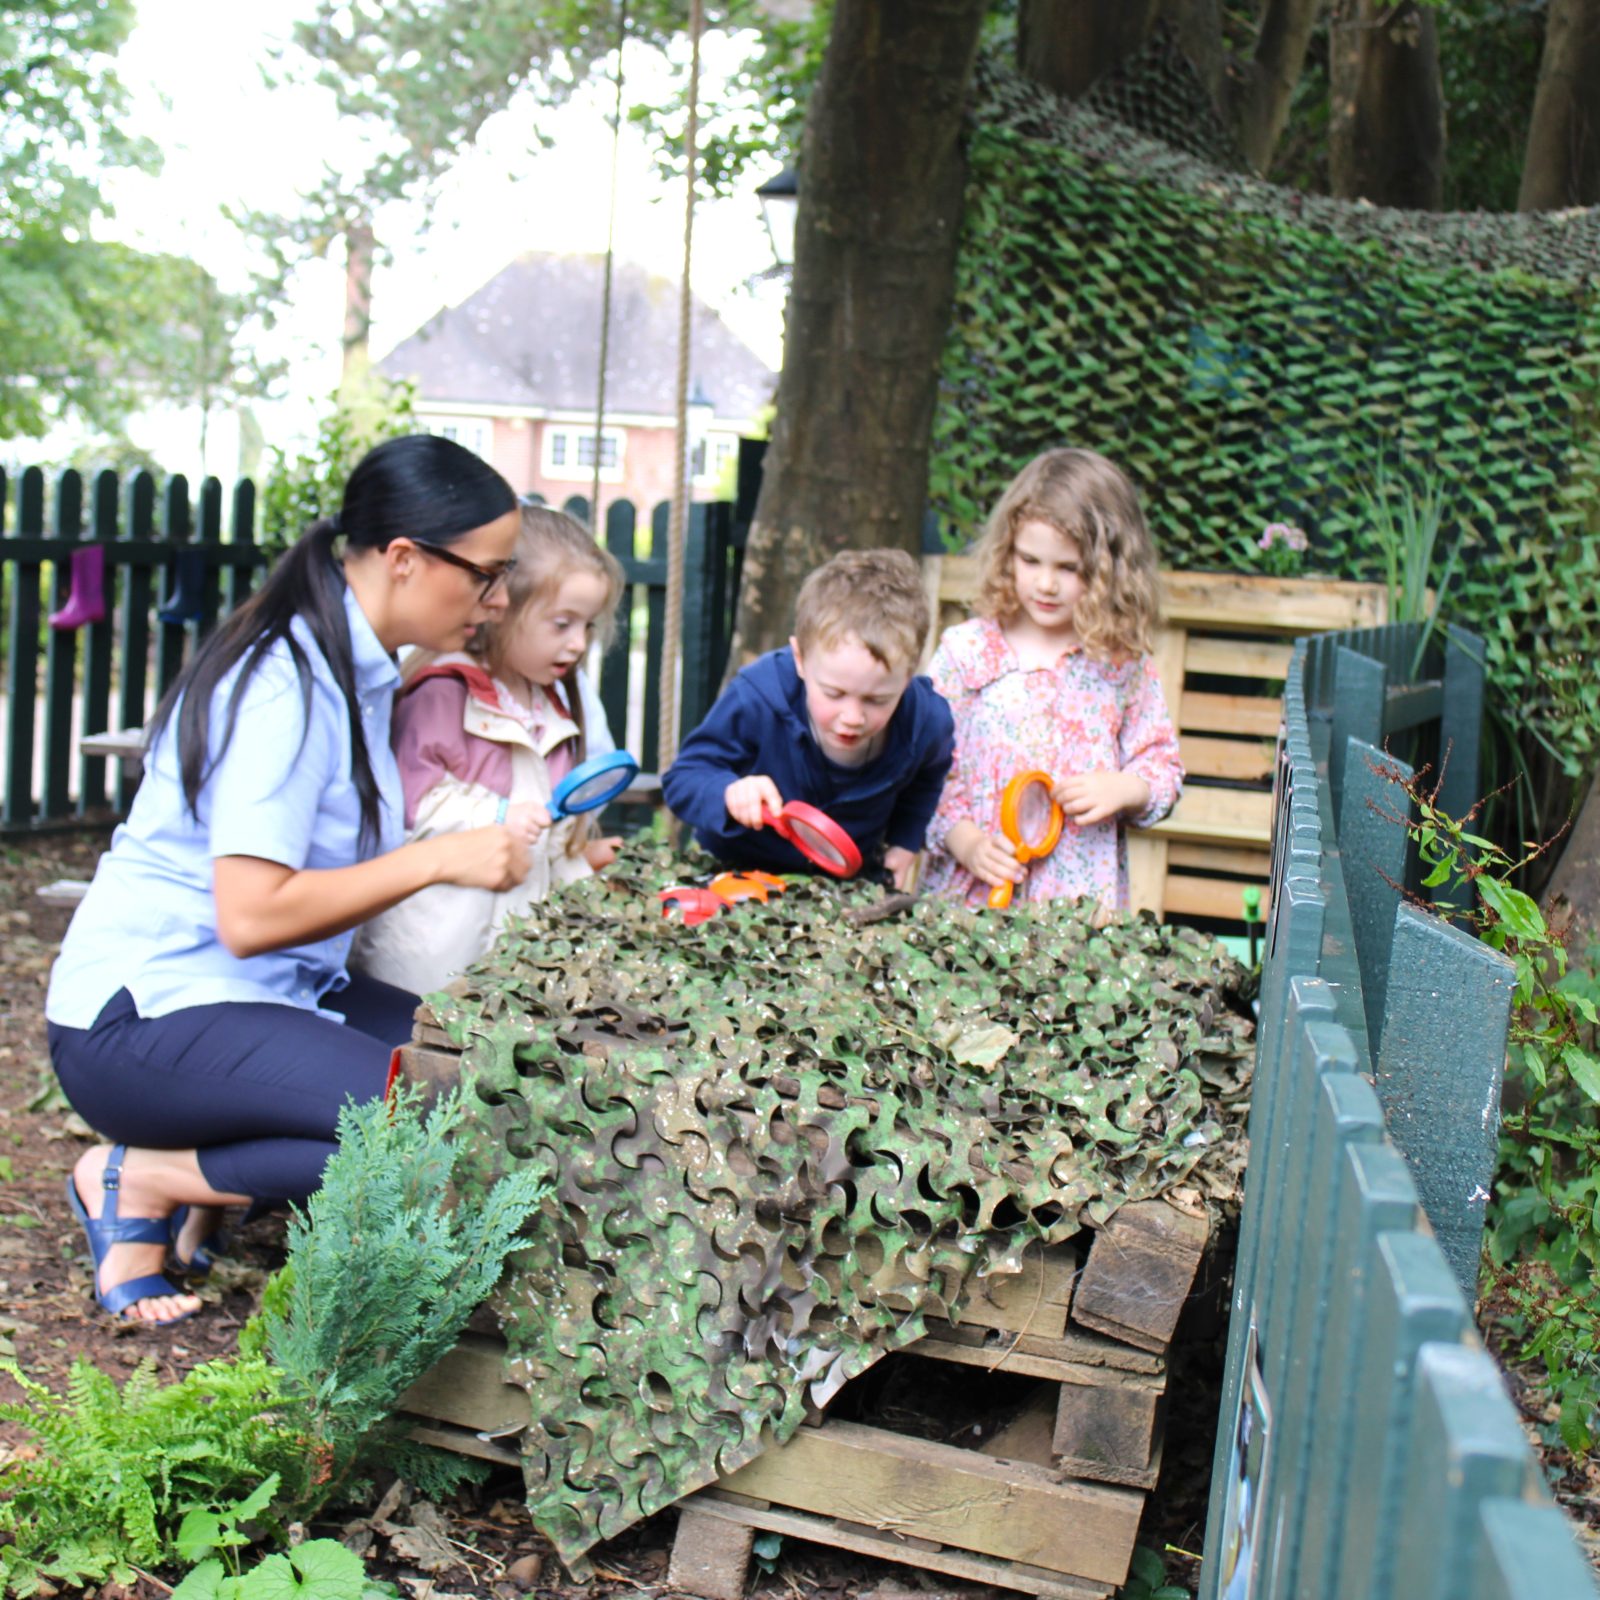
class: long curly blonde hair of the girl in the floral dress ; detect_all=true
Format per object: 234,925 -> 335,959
974,450 -> 1160,658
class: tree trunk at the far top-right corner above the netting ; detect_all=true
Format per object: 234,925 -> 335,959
1517,0 -> 1600,211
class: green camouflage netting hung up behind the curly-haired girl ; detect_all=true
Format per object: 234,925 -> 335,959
933,62 -> 1600,774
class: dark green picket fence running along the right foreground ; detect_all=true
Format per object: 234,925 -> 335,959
1202,624 -> 1595,1600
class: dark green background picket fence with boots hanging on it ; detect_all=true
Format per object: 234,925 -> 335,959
0,467 -> 744,834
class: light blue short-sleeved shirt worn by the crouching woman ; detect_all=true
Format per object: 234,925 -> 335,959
45,589 -> 405,1027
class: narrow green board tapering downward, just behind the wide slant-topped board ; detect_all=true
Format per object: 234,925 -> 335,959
1339,739 -> 1414,1038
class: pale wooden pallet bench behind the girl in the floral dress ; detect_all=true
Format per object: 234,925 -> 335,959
925,555 -> 1389,922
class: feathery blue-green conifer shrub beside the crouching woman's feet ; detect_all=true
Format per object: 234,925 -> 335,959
264,1086 -> 546,1499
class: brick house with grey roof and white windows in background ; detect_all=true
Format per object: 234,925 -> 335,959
378,253 -> 778,509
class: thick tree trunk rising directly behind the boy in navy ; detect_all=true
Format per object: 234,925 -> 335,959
730,0 -> 987,670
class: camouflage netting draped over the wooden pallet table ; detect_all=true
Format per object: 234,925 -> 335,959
435,846 -> 1251,1562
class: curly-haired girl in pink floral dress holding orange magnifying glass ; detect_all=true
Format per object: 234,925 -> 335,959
925,450 -> 1182,910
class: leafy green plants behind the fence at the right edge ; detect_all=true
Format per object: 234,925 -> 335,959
1411,784 -> 1600,1454
